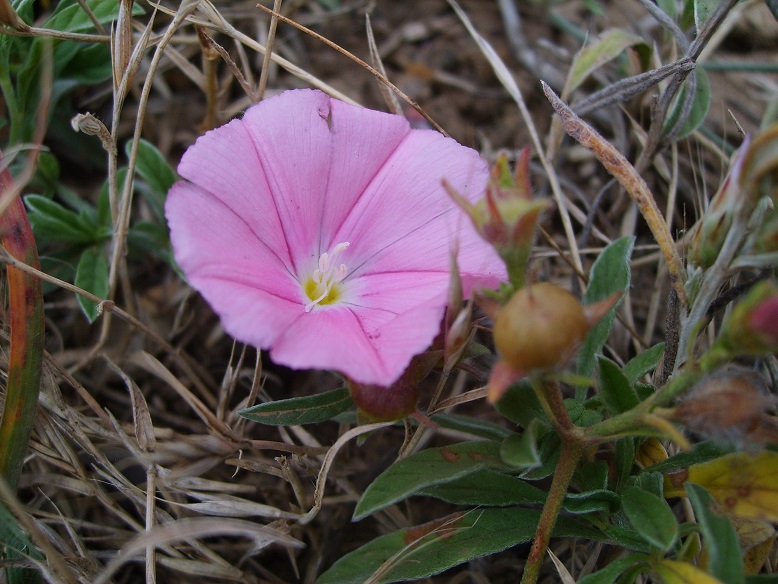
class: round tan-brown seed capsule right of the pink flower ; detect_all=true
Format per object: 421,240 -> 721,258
494,282 -> 590,373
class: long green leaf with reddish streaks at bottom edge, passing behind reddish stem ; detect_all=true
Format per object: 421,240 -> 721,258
316,507 -> 604,584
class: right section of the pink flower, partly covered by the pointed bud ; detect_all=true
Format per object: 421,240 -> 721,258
334,131 -> 506,292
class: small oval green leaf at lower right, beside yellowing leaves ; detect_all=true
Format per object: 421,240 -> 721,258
621,487 -> 678,551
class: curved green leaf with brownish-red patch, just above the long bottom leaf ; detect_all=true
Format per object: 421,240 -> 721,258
354,441 -> 507,521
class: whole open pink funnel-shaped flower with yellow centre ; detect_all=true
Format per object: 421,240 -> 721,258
166,90 -> 505,386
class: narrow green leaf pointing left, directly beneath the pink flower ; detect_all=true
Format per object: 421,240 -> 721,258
238,387 -> 354,426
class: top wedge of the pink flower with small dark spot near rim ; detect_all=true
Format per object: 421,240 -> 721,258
243,90 -> 410,270
